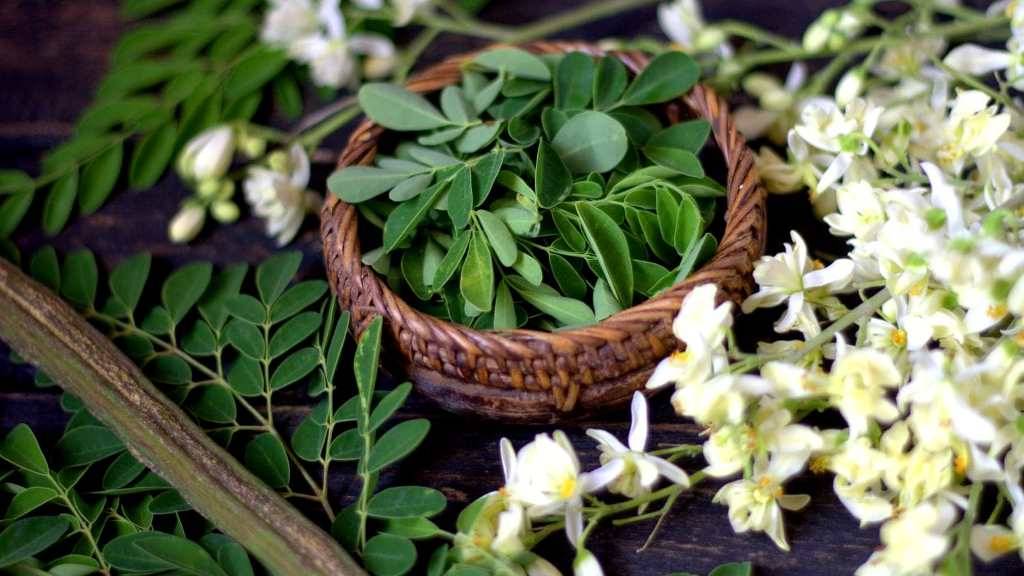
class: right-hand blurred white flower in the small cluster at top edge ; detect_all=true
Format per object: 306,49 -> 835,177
289,0 -> 394,88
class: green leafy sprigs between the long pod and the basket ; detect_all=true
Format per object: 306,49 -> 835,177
20,248 -> 446,575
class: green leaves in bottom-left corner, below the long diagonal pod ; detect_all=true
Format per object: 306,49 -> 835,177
0,416 -> 254,576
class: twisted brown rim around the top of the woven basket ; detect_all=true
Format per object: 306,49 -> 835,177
322,41 -> 765,416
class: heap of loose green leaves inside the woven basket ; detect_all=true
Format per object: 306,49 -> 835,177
328,48 -> 724,329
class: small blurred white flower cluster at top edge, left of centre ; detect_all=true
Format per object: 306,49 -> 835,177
260,0 -> 415,88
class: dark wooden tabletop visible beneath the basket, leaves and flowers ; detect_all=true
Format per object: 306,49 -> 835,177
0,0 -> 1020,575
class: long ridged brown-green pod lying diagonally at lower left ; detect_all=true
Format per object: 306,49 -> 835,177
0,258 -> 365,576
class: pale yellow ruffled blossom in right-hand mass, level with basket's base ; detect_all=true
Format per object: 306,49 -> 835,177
827,348 -> 903,438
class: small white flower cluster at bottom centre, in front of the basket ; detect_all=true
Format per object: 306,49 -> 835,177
456,393 -> 690,576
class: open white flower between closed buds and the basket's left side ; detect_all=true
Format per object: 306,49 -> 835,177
244,145 -> 319,246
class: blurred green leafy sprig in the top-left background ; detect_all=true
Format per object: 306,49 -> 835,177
0,0 -> 292,238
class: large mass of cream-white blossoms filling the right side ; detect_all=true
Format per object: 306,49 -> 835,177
648,2 -> 1024,576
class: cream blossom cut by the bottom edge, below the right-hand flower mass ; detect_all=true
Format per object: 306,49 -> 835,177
857,501 -> 956,576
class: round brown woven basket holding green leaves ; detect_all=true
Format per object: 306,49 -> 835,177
321,42 -> 766,422
